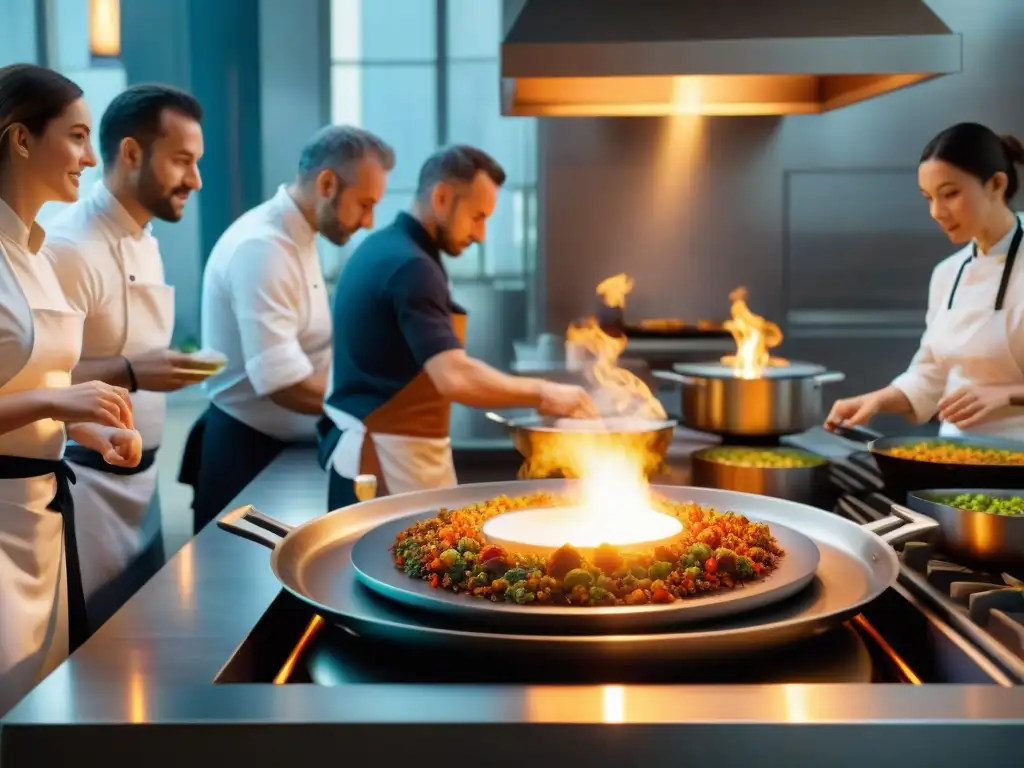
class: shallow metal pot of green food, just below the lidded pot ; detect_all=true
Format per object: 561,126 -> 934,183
690,445 -> 830,504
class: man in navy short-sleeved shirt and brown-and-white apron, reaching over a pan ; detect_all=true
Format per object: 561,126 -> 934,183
319,145 -> 596,509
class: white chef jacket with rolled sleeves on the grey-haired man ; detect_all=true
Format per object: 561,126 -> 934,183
197,185 -> 331,441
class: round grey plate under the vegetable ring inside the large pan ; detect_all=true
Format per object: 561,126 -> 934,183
352,514 -> 820,633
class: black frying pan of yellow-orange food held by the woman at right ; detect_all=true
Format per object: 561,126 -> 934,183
833,426 -> 1024,492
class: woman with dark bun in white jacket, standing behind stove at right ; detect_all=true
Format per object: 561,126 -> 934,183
825,123 -> 1024,439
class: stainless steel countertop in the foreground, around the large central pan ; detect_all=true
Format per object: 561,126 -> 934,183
0,438 -> 1024,768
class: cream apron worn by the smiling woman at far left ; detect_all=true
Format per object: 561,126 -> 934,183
0,299 -> 84,714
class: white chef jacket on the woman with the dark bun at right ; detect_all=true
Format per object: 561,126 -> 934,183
893,215 -> 1024,438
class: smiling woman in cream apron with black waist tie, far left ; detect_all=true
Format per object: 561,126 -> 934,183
0,65 -> 142,715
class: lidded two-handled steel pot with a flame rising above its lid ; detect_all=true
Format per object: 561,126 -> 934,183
654,362 -> 846,437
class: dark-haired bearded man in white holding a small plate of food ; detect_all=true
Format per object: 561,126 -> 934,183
46,85 -> 203,630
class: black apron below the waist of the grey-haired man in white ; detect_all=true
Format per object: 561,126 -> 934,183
178,406 -> 288,534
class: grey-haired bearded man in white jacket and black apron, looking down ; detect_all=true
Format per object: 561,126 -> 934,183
180,125 -> 394,532
